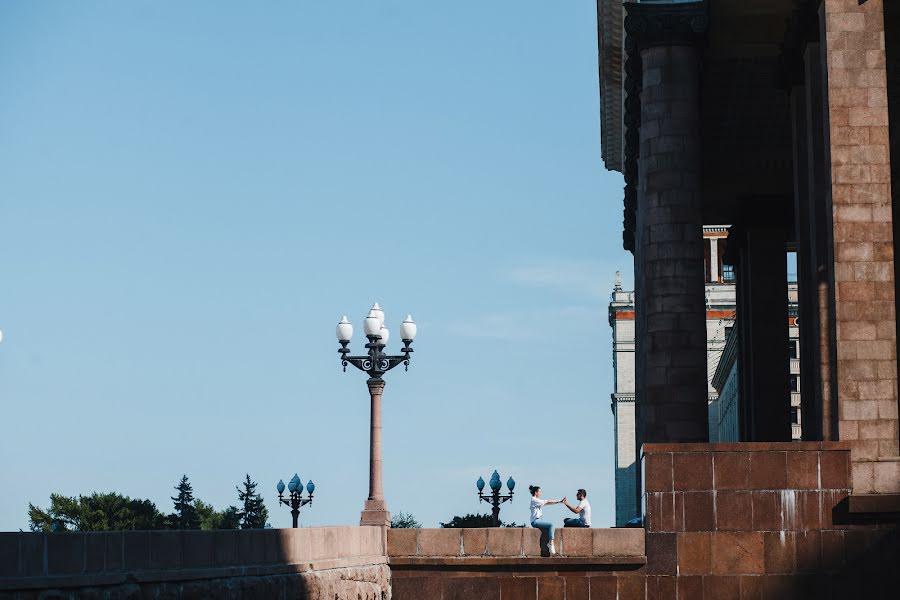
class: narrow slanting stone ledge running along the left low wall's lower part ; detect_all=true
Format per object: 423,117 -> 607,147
0,555 -> 388,590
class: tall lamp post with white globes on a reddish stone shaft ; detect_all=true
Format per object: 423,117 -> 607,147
335,302 -> 416,527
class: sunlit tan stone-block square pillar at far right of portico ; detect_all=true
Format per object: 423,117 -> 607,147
824,0 -> 900,476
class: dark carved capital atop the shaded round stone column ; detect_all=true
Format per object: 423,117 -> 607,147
624,0 -> 709,49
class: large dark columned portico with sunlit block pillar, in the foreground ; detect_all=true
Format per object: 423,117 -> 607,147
598,0 -> 900,494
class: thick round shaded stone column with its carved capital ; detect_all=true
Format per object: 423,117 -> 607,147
625,3 -> 709,444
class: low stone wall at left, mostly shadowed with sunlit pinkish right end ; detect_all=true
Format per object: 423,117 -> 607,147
0,527 -> 390,600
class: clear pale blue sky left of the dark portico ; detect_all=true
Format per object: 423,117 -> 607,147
0,0 -> 631,530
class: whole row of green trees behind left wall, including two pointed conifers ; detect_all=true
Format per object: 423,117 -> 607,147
28,474 -> 269,532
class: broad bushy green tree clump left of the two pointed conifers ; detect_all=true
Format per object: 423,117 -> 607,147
28,492 -> 165,531
